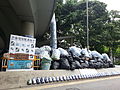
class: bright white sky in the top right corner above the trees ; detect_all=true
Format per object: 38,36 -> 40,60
99,0 -> 120,11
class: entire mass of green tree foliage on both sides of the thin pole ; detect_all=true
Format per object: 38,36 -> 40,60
55,0 -> 120,57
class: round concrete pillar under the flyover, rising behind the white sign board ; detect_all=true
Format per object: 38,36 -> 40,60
22,22 -> 34,37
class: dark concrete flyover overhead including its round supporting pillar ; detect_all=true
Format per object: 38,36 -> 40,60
0,0 -> 55,51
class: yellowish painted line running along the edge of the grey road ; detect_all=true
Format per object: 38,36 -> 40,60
12,76 -> 120,90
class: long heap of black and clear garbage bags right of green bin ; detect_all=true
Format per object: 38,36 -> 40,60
35,46 -> 114,70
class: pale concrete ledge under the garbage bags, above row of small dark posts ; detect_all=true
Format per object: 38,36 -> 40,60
0,67 -> 120,89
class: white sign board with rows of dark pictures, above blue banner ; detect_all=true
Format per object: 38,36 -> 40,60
9,35 -> 36,55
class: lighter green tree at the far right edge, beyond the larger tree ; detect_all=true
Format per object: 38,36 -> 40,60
102,10 -> 120,57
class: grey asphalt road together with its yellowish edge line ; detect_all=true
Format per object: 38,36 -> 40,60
16,76 -> 120,90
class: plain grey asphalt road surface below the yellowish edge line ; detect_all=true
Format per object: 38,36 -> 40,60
43,78 -> 120,90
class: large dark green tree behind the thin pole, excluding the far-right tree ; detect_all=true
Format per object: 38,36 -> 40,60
56,0 -> 109,49
